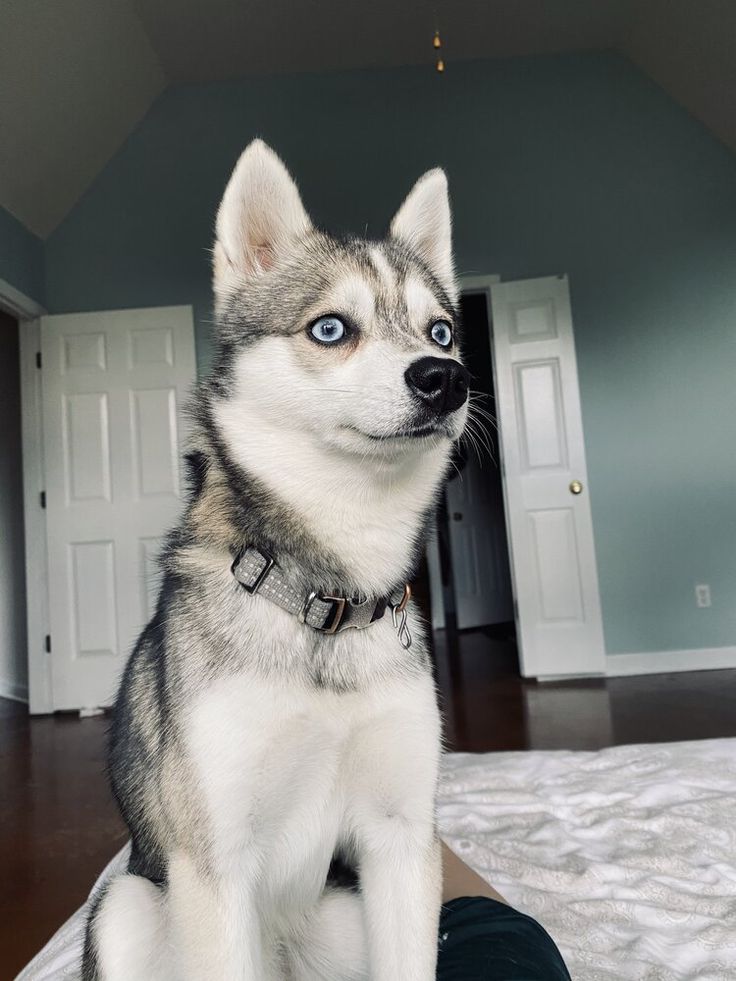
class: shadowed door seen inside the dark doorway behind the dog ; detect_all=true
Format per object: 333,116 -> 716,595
445,454 -> 514,630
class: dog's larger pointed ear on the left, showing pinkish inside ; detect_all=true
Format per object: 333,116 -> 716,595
214,140 -> 312,288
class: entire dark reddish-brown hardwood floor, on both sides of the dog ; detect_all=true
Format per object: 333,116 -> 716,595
0,633 -> 736,981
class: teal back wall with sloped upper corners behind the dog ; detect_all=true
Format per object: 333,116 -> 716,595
46,53 -> 736,653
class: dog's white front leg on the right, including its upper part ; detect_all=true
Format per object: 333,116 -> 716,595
347,676 -> 442,981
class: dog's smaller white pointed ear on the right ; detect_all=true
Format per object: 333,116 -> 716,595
391,168 -> 457,297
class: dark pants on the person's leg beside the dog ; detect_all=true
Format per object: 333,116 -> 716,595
437,896 -> 570,981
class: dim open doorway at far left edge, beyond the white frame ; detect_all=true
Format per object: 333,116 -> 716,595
0,309 -> 28,701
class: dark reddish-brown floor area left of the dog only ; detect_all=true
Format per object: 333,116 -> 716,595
0,699 -> 126,981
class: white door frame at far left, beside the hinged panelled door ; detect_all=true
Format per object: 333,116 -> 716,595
0,279 -> 53,714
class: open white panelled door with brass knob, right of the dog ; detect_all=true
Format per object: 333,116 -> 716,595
491,276 -> 605,677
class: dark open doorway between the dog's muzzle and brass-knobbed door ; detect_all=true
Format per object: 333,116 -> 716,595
430,289 -> 519,674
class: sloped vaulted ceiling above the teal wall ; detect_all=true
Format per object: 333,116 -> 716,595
0,0 -> 736,237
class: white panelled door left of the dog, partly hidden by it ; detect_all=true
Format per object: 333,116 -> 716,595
41,307 -> 195,709
